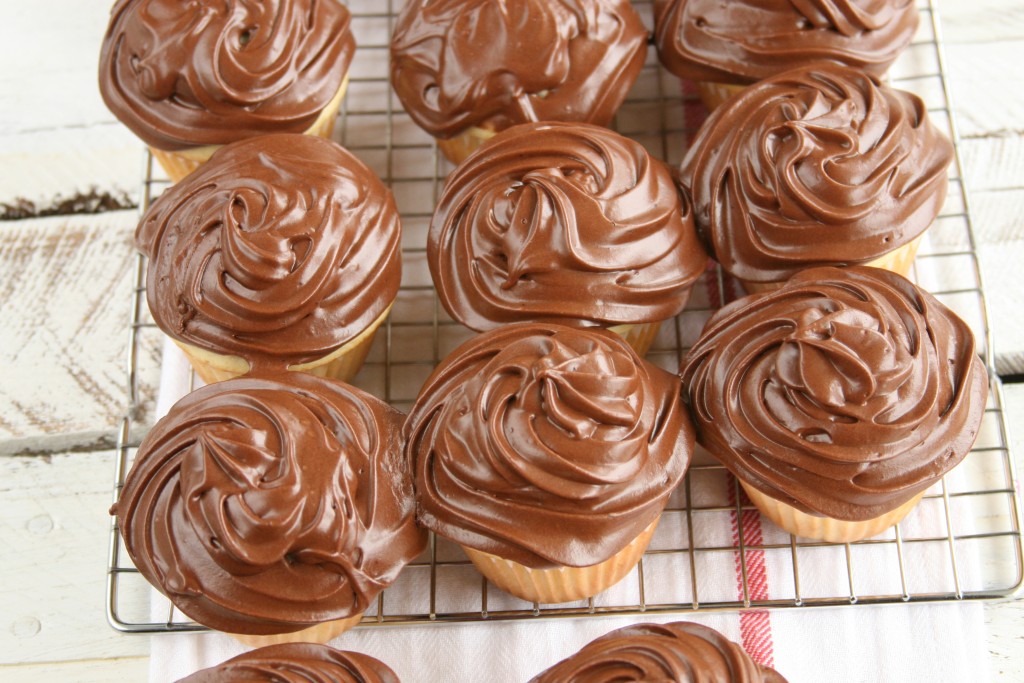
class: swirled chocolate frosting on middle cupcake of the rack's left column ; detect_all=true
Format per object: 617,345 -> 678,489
135,134 -> 401,367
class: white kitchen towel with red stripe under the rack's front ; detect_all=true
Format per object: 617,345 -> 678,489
144,342 -> 989,683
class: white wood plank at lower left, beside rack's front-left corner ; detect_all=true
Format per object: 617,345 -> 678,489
0,451 -> 148,664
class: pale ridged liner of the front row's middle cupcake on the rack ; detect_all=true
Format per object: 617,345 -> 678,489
463,515 -> 660,603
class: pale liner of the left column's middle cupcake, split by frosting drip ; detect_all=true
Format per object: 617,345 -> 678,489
171,302 -> 394,384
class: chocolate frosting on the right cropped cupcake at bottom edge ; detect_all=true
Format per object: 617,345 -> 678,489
529,622 -> 785,683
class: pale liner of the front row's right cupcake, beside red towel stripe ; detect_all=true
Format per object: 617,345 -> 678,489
739,481 -> 925,543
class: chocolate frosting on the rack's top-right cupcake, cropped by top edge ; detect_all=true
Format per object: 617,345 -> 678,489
654,0 -> 918,83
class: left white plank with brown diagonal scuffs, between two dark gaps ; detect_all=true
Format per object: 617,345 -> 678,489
0,211 -> 159,447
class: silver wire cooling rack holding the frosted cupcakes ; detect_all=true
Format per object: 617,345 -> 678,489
106,0 -> 1024,633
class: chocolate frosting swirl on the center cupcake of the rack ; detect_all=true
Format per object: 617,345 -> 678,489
427,123 -> 708,330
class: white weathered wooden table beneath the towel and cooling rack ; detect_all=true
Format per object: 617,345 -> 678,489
0,0 -> 1024,681
